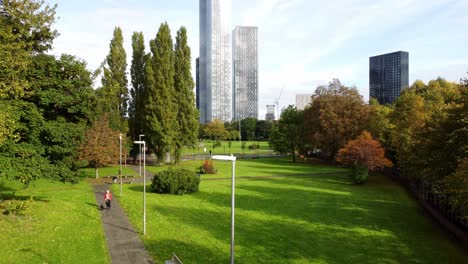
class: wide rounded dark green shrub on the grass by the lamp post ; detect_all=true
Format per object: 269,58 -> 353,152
151,169 -> 200,195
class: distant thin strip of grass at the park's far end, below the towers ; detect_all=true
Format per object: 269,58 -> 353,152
182,140 -> 273,155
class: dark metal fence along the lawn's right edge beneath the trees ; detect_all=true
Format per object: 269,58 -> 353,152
383,167 -> 468,244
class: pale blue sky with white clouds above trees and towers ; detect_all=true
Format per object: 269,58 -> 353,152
49,0 -> 468,119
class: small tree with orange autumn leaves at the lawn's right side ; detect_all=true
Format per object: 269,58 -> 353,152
336,131 -> 393,184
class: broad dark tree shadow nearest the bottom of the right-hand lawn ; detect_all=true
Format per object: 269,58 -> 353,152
151,203 -> 414,263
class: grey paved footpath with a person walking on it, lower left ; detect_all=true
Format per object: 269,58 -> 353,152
94,184 -> 154,264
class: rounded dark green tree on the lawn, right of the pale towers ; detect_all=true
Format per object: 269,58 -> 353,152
269,105 -> 304,162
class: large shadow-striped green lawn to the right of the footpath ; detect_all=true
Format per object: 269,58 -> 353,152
114,159 -> 467,263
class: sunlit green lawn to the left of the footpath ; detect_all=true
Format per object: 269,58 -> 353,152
0,179 -> 110,263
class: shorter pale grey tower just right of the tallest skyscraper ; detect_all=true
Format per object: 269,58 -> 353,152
232,26 -> 258,120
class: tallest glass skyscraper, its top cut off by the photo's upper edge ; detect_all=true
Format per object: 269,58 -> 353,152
198,0 -> 232,123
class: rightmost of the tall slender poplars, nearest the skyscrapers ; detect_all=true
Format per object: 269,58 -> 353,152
174,27 -> 198,163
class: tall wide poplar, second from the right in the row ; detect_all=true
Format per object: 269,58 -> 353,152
145,23 -> 178,161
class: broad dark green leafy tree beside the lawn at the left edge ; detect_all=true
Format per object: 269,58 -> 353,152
0,54 -> 95,184
